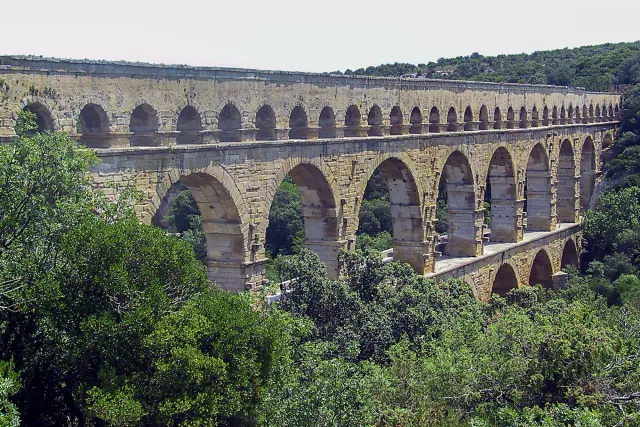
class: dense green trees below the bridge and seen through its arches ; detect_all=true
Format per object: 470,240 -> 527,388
0,53 -> 640,427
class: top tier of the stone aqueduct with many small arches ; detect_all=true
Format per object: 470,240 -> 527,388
0,56 -> 620,147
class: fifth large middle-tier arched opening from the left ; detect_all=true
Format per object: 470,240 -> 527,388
485,147 -> 518,243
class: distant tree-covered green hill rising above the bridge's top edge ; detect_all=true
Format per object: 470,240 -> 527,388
344,41 -> 640,91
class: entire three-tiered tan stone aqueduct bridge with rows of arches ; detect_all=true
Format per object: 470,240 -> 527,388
0,56 -> 620,299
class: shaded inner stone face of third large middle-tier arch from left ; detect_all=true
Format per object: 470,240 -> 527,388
358,154 -> 427,274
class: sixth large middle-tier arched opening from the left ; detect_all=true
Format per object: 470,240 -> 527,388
524,144 -> 552,231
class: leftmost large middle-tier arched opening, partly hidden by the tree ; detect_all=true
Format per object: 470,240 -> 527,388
153,173 -> 246,291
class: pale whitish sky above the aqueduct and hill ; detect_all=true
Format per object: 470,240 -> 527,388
6,0 -> 640,72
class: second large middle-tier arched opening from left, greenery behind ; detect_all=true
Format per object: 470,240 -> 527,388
265,163 -> 341,278
